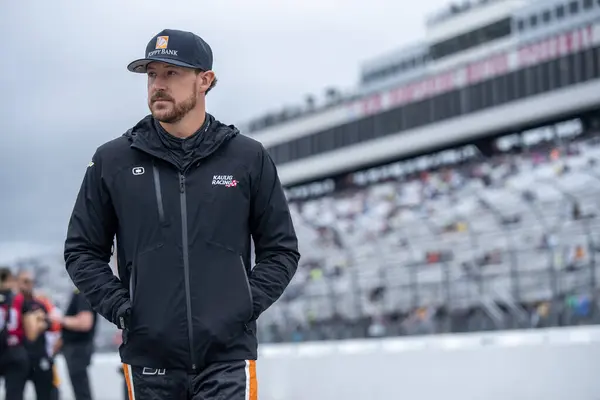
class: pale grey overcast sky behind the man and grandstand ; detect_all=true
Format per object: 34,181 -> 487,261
0,0 -> 447,261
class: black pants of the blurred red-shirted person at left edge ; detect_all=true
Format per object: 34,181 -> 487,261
0,346 -> 29,400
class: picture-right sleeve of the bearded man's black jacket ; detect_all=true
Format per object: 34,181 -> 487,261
249,146 -> 300,320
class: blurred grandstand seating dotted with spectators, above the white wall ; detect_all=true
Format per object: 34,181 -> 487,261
260,135 -> 600,342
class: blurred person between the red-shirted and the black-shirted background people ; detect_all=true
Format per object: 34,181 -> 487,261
17,271 -> 60,400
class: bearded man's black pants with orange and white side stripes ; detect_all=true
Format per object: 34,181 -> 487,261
124,361 -> 258,400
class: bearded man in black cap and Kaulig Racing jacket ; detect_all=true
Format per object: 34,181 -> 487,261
65,29 -> 300,400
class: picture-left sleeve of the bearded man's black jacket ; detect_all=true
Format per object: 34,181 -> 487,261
64,151 -> 129,325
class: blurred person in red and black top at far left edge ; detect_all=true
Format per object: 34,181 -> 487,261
0,268 -> 47,400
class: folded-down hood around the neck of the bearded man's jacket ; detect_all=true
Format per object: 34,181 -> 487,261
123,113 -> 239,164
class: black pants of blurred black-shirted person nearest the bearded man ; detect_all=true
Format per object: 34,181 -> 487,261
62,342 -> 94,400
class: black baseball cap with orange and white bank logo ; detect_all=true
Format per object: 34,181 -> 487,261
127,29 -> 212,74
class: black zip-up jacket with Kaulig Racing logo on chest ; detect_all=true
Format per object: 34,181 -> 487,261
65,116 -> 300,371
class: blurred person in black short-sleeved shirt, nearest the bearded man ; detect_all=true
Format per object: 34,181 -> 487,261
52,290 -> 97,400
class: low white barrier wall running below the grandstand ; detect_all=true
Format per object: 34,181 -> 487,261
16,327 -> 600,400
